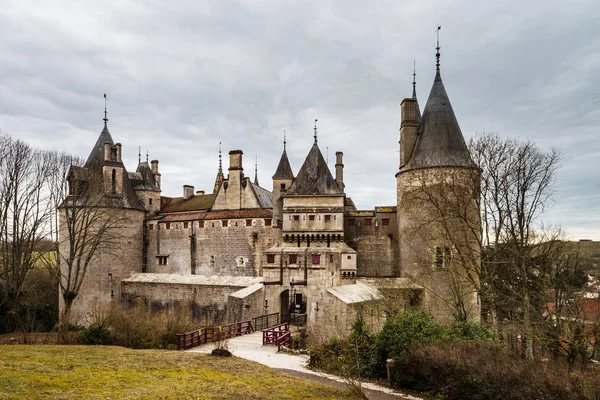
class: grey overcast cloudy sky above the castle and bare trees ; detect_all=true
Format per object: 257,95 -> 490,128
0,0 -> 600,240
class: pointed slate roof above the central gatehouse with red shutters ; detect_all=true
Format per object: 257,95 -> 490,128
288,140 -> 344,194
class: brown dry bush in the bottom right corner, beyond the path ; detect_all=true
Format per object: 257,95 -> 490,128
392,341 -> 600,400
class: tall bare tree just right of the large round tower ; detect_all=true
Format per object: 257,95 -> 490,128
469,134 -> 560,357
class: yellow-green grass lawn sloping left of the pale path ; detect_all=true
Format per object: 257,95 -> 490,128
0,345 -> 353,399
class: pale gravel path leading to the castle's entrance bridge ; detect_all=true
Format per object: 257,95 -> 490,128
187,332 -> 422,400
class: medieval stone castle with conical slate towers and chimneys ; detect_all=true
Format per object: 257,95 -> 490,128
59,51 -> 480,341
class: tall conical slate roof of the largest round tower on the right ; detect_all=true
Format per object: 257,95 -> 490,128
403,71 -> 475,170
